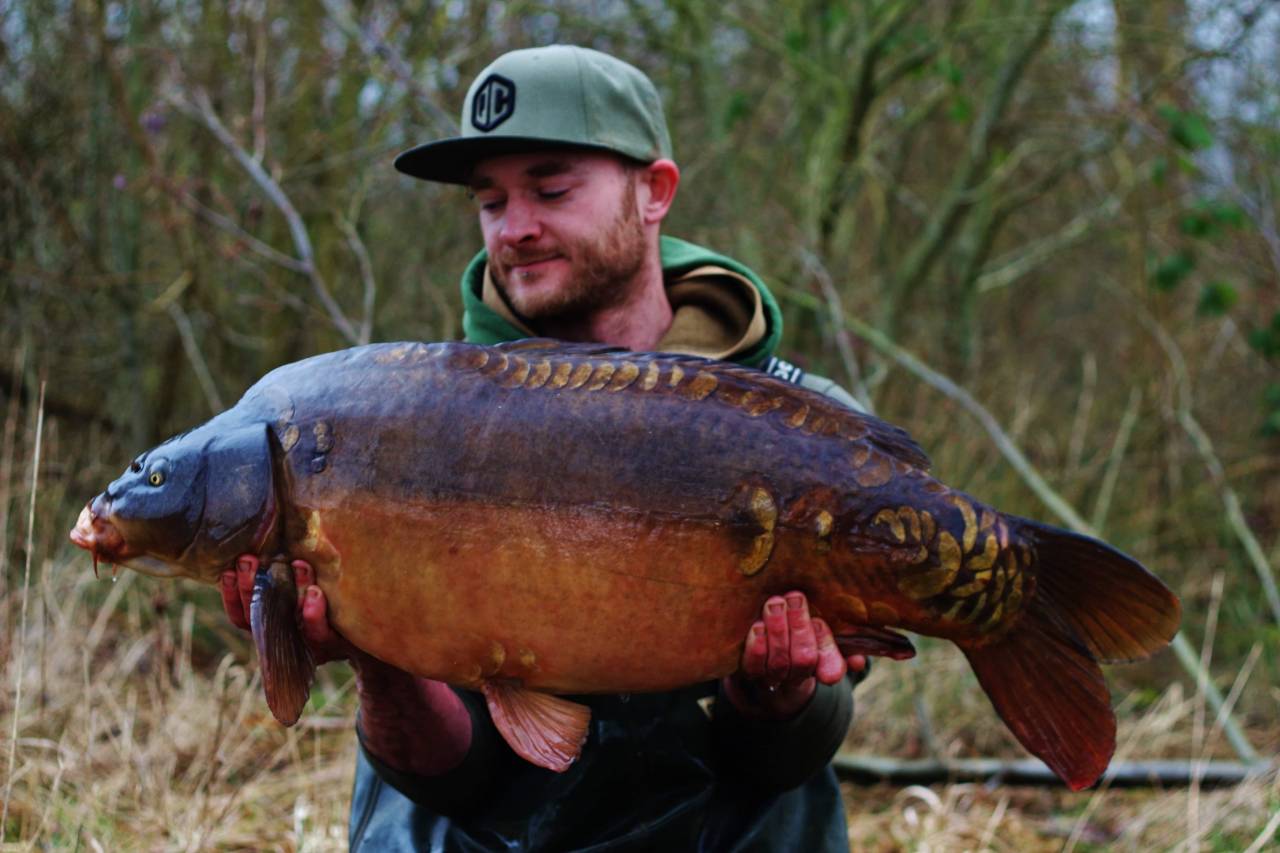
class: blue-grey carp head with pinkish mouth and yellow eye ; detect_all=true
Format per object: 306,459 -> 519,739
70,421 -> 275,583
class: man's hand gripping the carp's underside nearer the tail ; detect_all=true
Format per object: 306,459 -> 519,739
723,590 -> 867,720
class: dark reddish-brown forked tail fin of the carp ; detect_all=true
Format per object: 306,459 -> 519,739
961,519 -> 1181,790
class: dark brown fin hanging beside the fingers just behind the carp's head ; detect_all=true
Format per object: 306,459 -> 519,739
248,560 -> 316,726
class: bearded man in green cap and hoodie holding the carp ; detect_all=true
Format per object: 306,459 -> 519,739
223,46 -> 865,850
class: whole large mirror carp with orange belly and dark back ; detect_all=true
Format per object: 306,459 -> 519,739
72,341 -> 1180,788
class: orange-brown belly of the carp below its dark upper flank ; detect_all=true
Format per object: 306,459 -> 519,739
296,491 -> 785,693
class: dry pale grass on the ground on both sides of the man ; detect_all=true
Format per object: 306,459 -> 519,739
0,394 -> 1280,853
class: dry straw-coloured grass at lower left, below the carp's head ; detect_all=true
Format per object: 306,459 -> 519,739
0,558 -> 353,850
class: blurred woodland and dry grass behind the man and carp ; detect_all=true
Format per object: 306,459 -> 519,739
0,0 -> 1280,850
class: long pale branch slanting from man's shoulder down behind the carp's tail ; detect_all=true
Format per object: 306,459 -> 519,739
774,286 -> 1258,762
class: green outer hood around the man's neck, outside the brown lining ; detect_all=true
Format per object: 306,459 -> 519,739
462,237 -> 782,368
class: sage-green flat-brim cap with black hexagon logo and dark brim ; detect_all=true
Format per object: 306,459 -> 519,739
396,45 -> 671,183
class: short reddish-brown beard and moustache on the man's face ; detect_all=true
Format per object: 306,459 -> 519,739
489,183 -> 648,320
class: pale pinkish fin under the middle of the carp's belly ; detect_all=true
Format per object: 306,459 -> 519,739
484,681 -> 591,774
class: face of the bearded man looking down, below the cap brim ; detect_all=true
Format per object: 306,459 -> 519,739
471,150 -> 646,320
